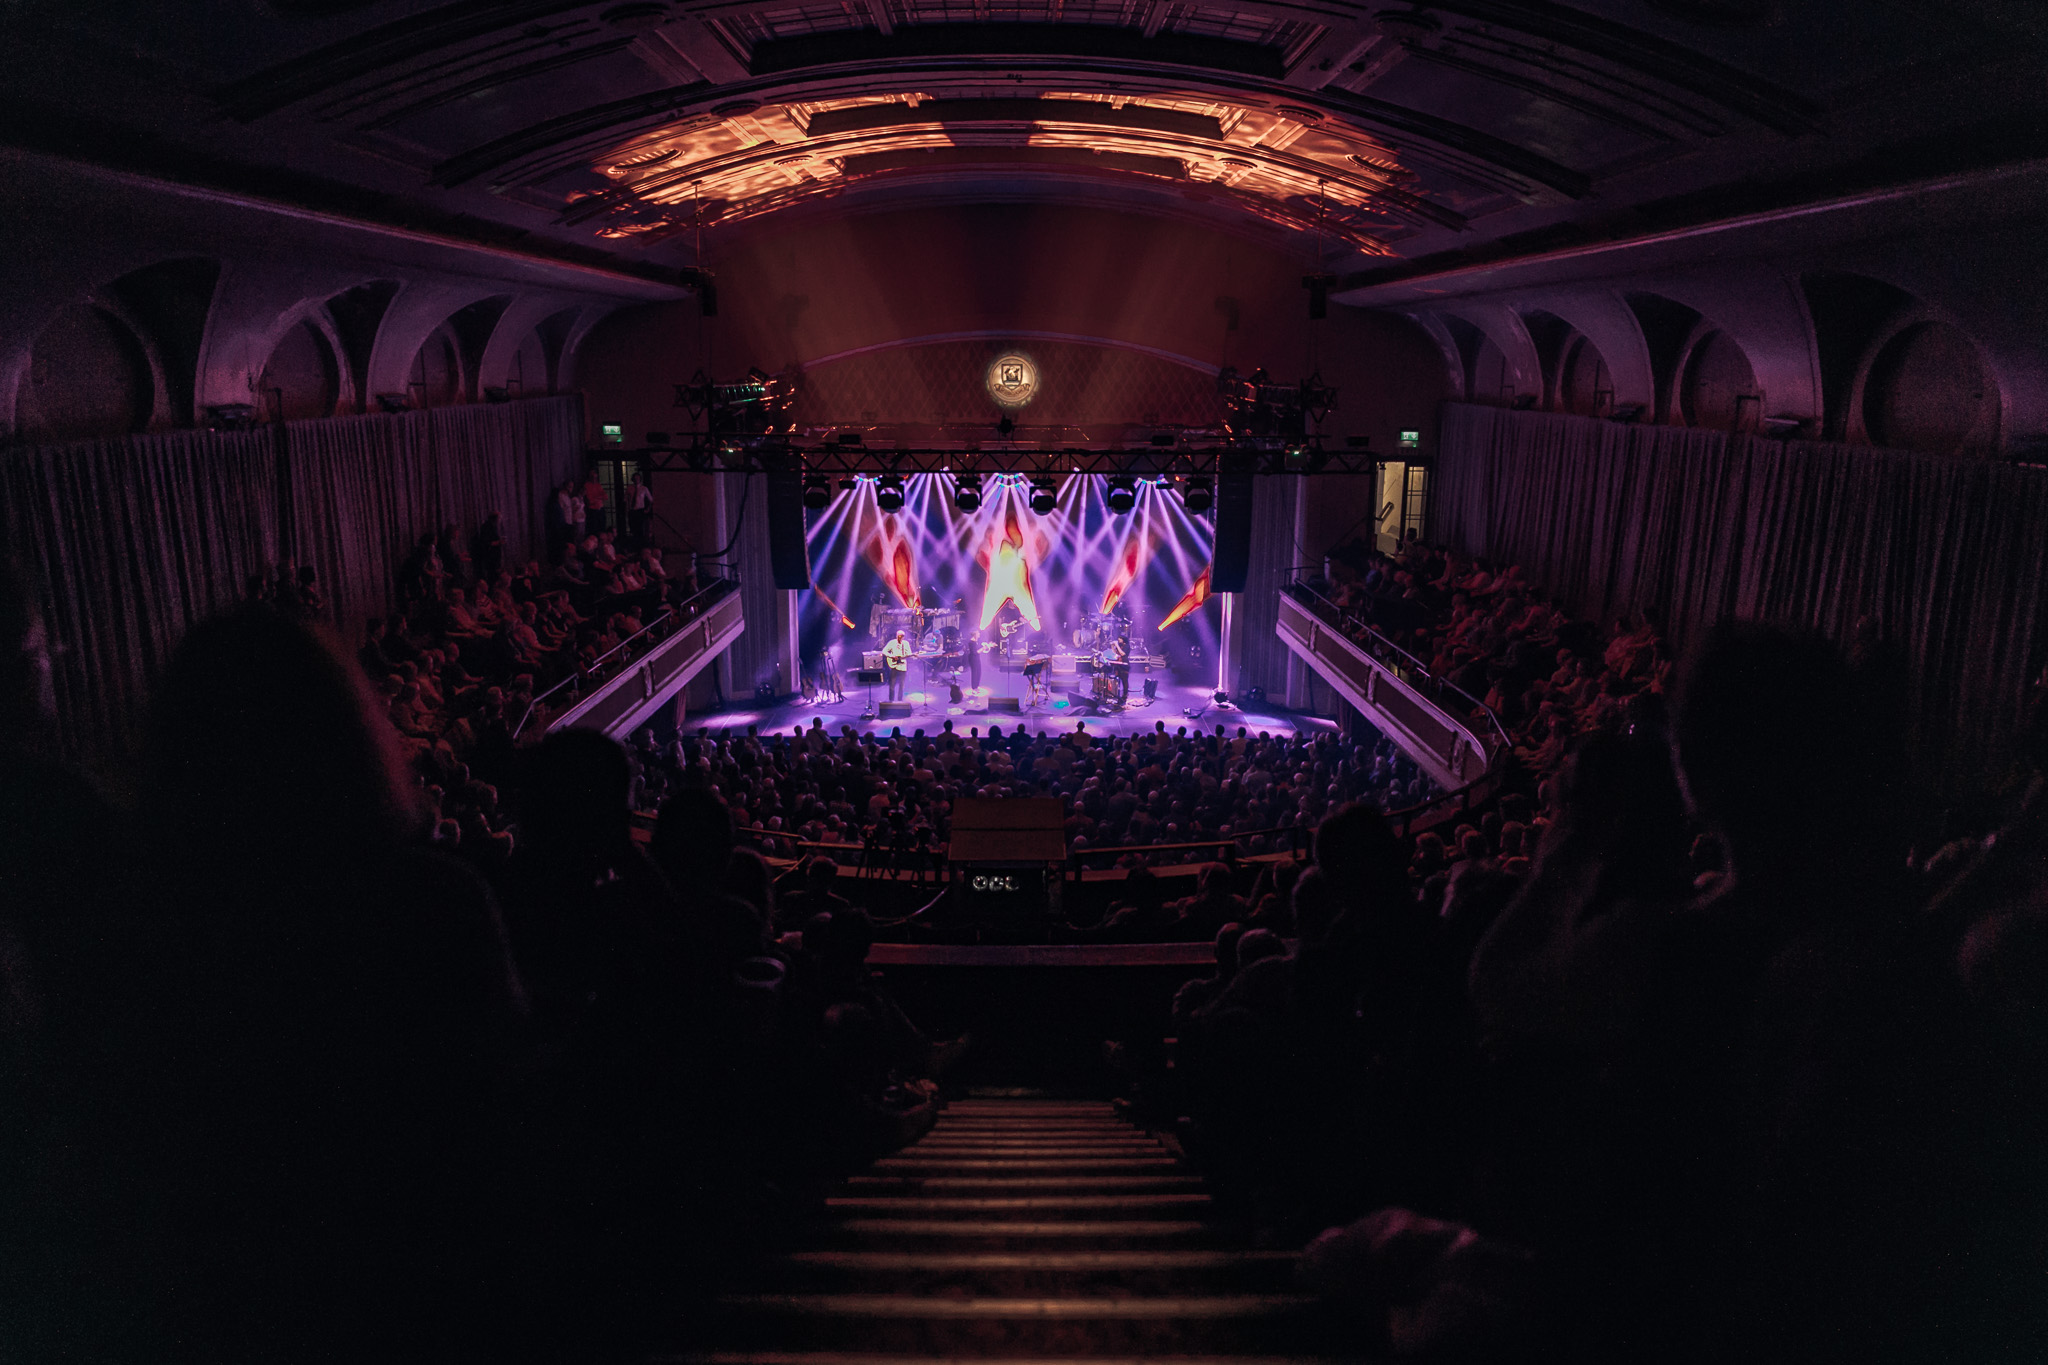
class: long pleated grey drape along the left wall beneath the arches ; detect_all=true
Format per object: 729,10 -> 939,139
0,397 -> 582,759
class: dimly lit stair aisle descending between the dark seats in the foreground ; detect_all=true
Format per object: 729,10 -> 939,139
659,1099 -> 1329,1365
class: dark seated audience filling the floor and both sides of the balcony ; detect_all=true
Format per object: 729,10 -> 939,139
0,505 -> 2048,1363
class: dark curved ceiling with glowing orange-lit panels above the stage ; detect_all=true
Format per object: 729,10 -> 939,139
0,0 -> 2048,278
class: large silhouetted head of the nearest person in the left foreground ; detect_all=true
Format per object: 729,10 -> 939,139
143,610 -> 420,855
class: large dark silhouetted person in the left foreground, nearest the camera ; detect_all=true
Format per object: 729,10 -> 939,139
115,614 -> 524,1361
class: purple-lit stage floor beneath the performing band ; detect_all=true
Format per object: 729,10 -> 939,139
684,673 -> 1337,735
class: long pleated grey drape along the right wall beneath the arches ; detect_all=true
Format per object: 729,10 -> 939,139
1432,403 -> 2048,790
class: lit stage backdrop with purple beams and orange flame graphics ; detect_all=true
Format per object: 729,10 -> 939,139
801,475 -> 1219,684
